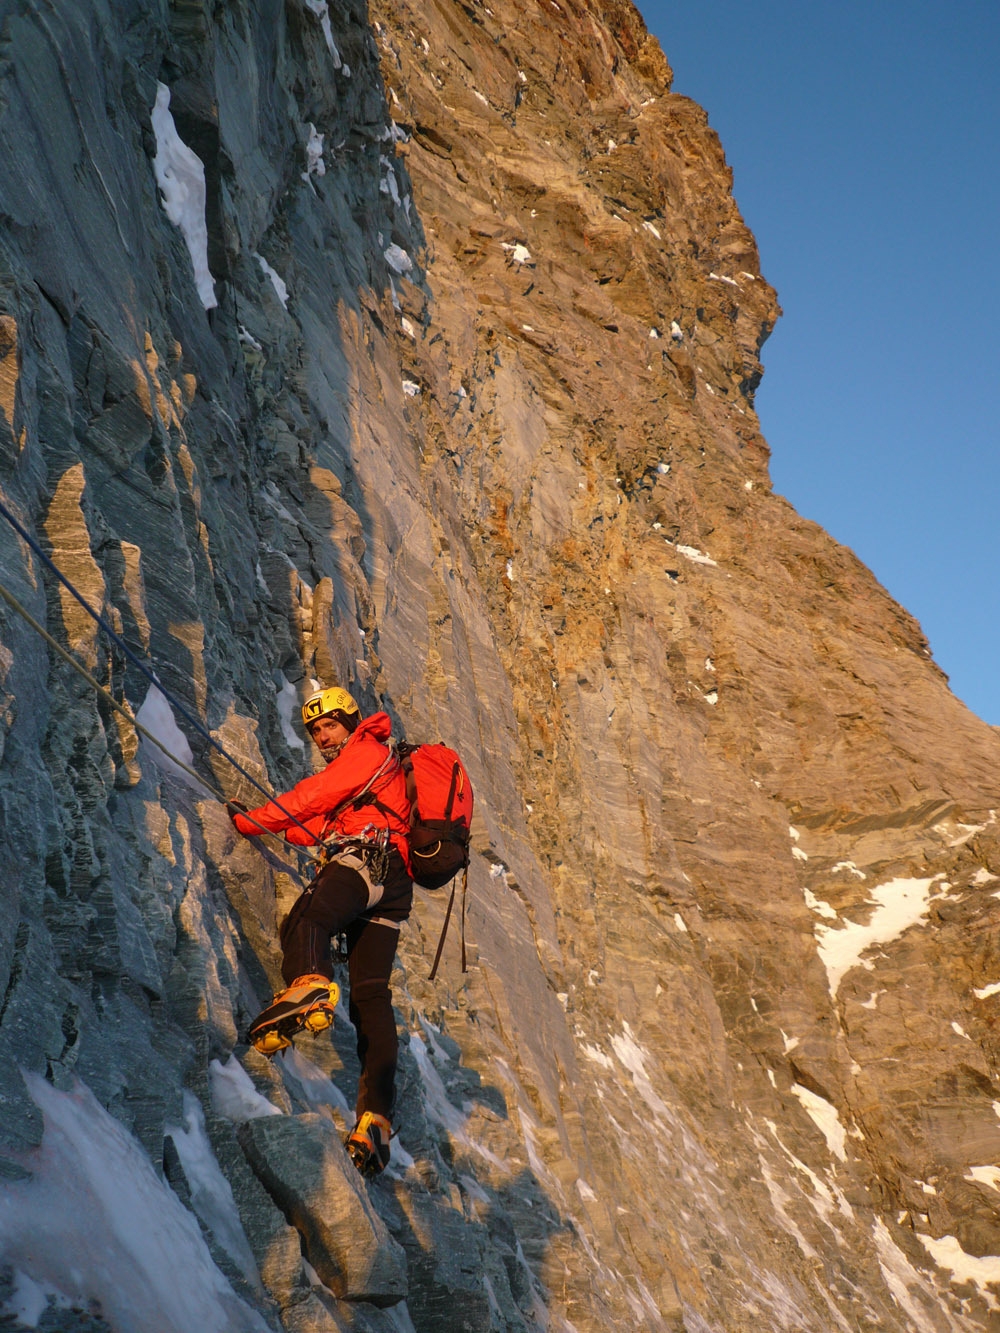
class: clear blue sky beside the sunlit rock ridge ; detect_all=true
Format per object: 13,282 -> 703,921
639,0 -> 1000,724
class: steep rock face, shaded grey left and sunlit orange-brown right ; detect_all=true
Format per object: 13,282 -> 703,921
0,0 -> 1000,1333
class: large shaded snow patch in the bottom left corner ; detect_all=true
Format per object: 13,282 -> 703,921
0,1073 -> 268,1333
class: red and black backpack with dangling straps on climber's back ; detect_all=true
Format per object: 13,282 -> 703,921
396,741 -> 472,981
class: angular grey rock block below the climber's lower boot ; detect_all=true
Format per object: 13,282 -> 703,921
237,1114 -> 407,1305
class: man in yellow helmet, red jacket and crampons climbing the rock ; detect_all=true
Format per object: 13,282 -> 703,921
228,688 -> 413,1176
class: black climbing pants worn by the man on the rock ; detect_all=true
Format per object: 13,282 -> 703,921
280,850 -> 413,1118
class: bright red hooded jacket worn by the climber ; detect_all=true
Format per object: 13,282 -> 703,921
233,713 -> 409,872
